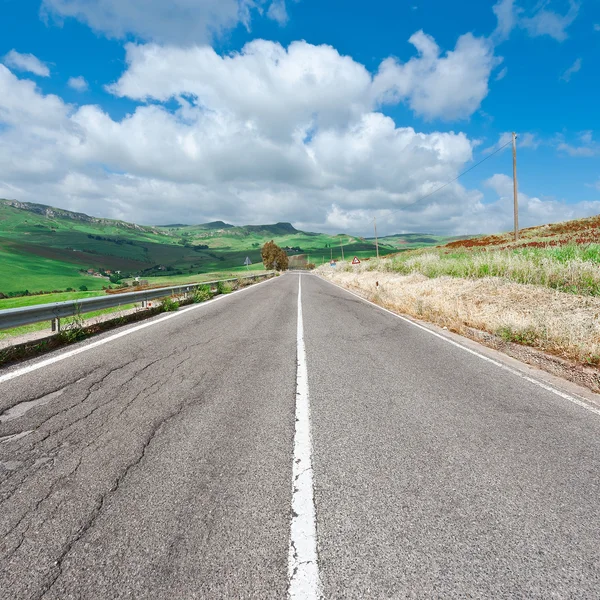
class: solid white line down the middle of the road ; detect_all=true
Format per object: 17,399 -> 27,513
288,275 -> 321,600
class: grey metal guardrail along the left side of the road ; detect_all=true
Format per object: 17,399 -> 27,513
0,272 -> 273,331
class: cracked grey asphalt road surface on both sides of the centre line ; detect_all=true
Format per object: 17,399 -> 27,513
0,274 -> 600,600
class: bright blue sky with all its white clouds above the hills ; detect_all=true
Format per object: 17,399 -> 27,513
0,0 -> 600,235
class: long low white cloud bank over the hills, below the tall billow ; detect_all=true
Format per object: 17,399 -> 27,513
0,60 -> 482,233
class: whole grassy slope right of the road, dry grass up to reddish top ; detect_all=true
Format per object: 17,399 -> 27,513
322,216 -> 600,366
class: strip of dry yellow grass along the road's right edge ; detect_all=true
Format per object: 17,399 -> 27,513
317,264 -> 600,365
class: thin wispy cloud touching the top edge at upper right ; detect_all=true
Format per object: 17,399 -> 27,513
492,0 -> 580,43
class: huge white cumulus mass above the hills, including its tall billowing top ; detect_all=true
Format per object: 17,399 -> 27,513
0,42 -> 580,235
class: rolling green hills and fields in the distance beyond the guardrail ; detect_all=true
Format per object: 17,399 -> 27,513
0,200 -> 460,298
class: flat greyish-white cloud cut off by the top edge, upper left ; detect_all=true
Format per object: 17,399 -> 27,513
42,0 -> 294,44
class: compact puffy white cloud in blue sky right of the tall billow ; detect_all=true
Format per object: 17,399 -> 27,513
373,31 -> 500,120
